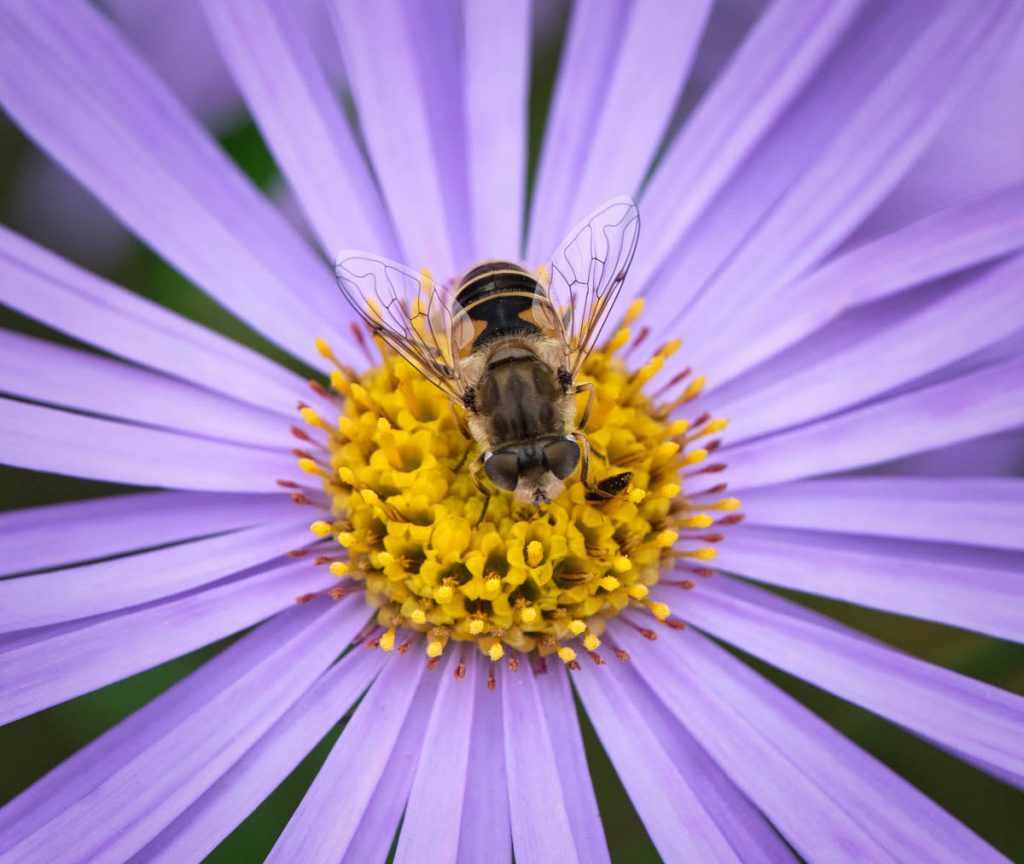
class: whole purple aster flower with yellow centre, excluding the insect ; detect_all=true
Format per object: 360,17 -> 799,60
0,0 -> 1024,862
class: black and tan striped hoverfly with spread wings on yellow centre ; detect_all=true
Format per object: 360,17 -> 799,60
335,197 -> 640,519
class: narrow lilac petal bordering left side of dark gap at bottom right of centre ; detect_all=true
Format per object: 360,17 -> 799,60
536,663 -> 608,863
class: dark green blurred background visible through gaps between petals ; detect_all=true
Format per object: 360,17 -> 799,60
0,5 -> 1024,862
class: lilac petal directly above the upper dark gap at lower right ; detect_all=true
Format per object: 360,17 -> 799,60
715,528 -> 1024,642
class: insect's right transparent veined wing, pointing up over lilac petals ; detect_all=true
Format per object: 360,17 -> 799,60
548,196 -> 640,376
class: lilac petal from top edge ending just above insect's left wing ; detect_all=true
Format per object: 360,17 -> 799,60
204,0 -> 396,258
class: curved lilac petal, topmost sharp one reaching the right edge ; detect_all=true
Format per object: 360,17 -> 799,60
701,184 -> 1024,387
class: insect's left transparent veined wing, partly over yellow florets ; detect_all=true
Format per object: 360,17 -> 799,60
334,252 -> 465,399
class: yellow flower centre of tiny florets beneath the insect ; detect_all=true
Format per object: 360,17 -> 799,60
299,302 -> 740,669
